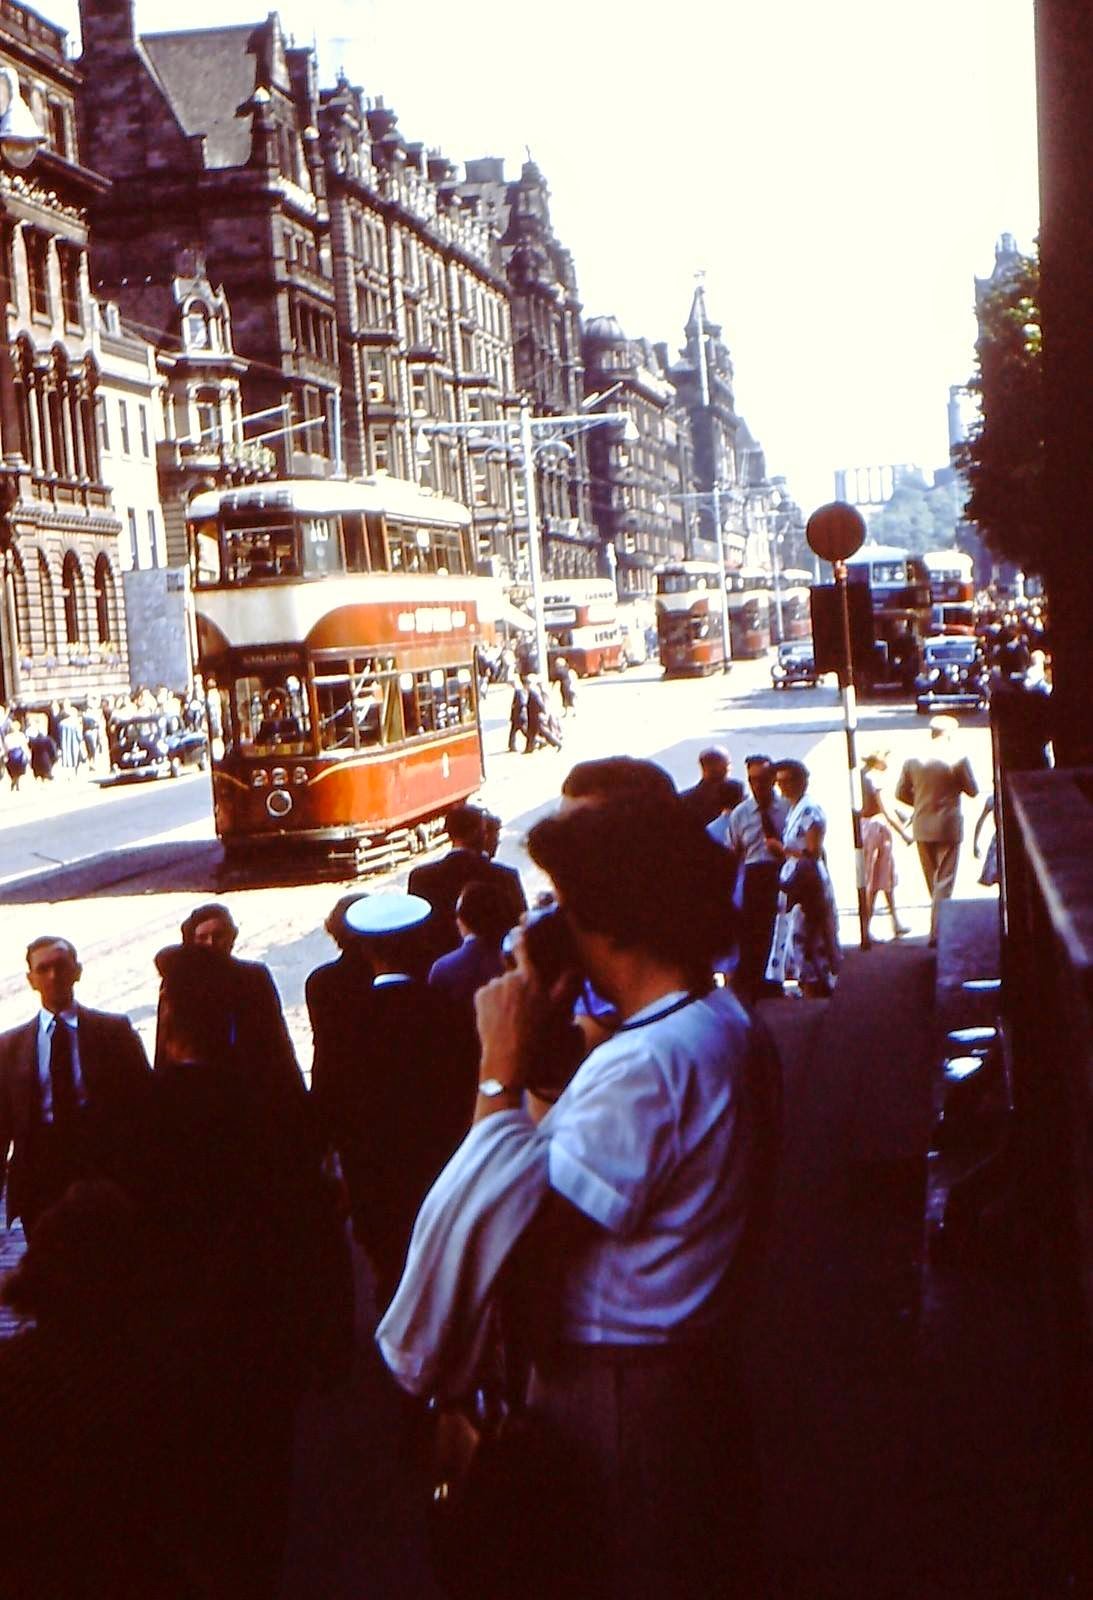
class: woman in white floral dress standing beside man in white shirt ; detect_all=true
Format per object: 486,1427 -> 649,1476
767,762 -> 840,1000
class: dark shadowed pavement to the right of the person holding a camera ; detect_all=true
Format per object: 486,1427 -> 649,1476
754,906 -> 1071,1600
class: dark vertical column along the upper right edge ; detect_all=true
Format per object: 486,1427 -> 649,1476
1035,0 -> 1093,766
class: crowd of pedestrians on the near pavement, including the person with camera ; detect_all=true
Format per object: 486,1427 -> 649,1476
0,720 -> 1011,1600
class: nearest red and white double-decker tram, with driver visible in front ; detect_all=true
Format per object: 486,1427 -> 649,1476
189,478 -> 482,867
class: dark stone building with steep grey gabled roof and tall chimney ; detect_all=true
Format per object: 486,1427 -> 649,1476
80,0 -> 341,475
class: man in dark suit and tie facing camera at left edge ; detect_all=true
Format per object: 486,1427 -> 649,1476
0,934 -> 152,1234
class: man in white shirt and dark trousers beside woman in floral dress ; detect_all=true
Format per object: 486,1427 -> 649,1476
725,755 -> 789,1005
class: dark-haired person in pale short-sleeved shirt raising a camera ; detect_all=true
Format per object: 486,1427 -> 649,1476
475,795 -> 781,1600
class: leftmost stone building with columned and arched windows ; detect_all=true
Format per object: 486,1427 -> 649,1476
0,0 -> 128,706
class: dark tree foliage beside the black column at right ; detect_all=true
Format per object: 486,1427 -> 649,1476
959,246 -> 1045,573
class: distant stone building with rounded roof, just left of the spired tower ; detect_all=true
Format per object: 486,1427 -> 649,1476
584,317 -> 687,600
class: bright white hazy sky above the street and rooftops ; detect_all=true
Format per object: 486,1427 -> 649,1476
51,0 -> 1039,510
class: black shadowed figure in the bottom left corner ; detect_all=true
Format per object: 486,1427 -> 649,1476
0,1182 -> 193,1600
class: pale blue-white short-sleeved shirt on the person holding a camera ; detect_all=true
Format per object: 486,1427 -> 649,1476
542,989 -> 752,1344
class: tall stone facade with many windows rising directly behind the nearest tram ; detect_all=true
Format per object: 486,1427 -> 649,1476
320,78 -> 517,571
